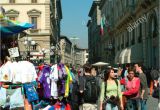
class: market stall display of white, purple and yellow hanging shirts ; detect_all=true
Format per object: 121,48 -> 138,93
0,61 -> 75,110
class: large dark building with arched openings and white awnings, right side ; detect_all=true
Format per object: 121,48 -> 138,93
100,0 -> 160,69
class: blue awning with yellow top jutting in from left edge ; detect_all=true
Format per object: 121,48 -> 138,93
0,18 -> 34,37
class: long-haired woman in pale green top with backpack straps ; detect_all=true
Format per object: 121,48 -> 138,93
100,68 -> 123,110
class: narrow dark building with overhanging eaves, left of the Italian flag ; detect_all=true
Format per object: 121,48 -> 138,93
87,1 -> 102,63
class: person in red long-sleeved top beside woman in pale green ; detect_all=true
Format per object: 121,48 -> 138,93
120,68 -> 140,110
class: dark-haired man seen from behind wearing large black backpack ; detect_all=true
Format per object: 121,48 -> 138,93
79,64 -> 99,110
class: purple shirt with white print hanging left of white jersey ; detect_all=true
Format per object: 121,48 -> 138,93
39,66 -> 51,98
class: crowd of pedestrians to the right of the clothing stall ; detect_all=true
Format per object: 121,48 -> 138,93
74,63 -> 160,110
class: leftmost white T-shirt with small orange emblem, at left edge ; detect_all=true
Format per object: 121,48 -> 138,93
0,61 -> 13,82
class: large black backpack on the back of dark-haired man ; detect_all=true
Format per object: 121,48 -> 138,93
83,76 -> 100,103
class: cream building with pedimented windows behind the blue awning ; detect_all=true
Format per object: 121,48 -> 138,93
0,0 -> 62,63
